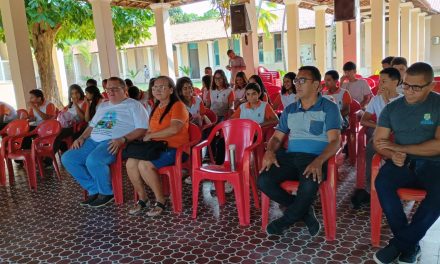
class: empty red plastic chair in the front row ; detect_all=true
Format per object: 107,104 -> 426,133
192,119 -> 263,226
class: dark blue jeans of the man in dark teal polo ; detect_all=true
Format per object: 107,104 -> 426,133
375,159 -> 440,251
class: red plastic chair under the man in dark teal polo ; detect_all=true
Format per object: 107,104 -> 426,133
370,154 -> 426,247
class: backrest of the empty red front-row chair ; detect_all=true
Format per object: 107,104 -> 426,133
209,119 -> 263,167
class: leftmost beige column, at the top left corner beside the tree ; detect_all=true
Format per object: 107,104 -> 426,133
0,0 -> 37,108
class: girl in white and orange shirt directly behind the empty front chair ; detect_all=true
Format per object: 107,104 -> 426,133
231,83 -> 278,127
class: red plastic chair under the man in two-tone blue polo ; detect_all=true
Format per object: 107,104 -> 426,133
261,149 -> 341,241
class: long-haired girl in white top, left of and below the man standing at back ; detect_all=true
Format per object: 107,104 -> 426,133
207,70 -> 235,122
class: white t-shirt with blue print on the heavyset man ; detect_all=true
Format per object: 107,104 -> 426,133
89,98 -> 149,142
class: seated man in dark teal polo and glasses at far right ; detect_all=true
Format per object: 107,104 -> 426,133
374,62 -> 440,263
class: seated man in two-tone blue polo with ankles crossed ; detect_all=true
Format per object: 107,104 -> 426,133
258,66 -> 341,236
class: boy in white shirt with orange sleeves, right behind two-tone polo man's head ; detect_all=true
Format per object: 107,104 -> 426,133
323,70 -> 351,128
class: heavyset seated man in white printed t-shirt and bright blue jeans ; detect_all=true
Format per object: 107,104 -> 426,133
61,77 -> 148,207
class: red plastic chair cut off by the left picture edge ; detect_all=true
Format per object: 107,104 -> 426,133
0,119 -> 29,185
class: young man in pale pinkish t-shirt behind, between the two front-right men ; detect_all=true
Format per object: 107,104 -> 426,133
341,61 -> 373,109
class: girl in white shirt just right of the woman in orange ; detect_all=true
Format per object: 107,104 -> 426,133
176,77 -> 210,126
